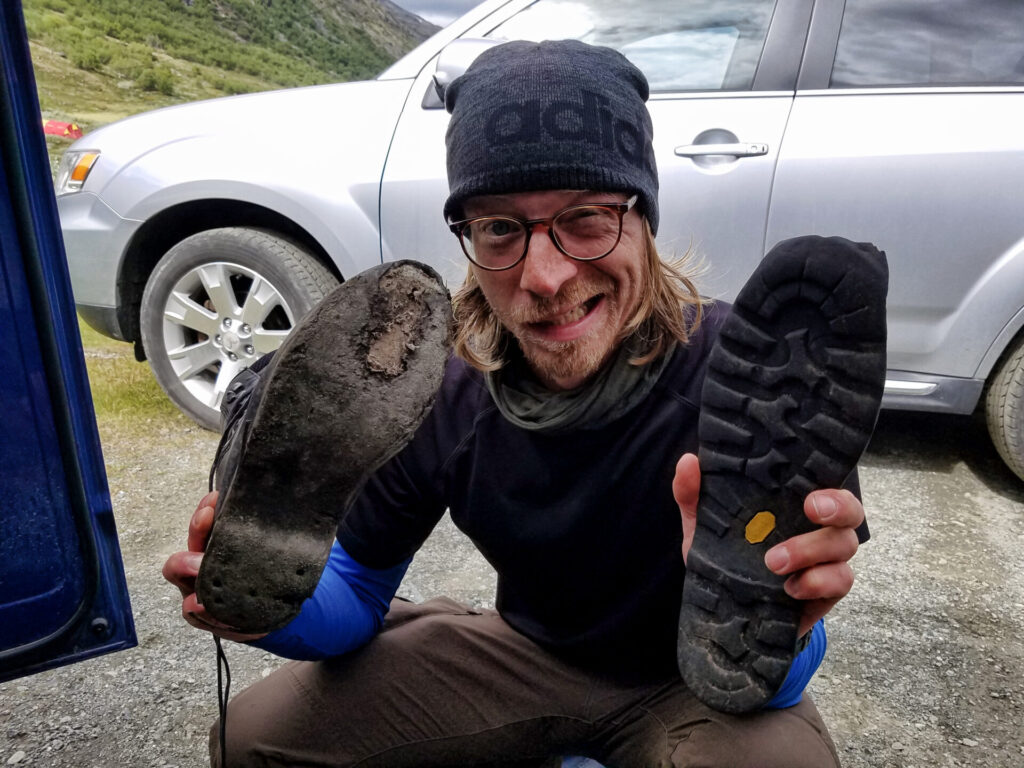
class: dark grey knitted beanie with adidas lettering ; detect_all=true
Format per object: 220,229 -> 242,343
444,40 -> 657,232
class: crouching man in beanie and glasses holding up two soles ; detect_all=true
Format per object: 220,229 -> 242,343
165,42 -> 864,768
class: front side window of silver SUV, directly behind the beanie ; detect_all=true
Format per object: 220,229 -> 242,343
479,0 -> 775,91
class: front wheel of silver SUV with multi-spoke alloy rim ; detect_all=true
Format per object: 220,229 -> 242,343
140,227 -> 338,430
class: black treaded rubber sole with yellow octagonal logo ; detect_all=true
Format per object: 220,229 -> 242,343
678,237 -> 889,713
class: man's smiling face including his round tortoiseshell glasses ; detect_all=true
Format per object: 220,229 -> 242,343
453,190 -> 646,391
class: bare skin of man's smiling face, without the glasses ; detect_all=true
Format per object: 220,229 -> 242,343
464,190 -> 646,390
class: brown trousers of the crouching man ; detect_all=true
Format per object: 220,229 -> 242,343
210,599 -> 839,768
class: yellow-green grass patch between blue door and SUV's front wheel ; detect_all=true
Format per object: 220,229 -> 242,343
78,318 -> 191,434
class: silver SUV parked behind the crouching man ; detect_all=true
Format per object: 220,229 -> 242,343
57,0 -> 1024,477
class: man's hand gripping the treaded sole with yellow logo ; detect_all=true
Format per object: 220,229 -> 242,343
672,454 -> 864,636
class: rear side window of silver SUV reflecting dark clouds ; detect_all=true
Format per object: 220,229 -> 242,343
830,0 -> 1024,88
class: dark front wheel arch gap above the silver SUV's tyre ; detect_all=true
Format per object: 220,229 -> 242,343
117,199 -> 344,360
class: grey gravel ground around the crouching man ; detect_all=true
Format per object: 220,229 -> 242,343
0,405 -> 1024,768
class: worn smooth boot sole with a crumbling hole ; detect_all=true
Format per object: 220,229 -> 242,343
197,261 -> 453,632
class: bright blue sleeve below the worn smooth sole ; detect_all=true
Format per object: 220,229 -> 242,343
249,541 -> 412,660
